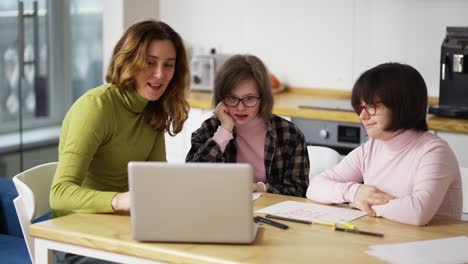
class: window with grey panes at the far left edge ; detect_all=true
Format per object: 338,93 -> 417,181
0,0 -> 49,133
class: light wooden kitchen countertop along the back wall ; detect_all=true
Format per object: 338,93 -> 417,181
188,88 -> 468,134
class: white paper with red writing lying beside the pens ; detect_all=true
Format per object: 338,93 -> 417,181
256,201 -> 366,222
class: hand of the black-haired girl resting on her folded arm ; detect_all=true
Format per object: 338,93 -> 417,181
350,184 -> 395,216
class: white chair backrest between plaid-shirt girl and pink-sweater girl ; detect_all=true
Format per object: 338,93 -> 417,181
307,146 -> 341,180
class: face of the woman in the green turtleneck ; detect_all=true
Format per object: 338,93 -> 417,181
135,40 -> 176,101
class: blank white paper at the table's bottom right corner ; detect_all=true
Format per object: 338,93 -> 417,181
366,236 -> 468,264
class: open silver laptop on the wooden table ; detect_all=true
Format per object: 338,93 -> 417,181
128,162 -> 257,244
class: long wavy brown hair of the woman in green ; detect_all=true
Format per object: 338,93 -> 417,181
106,20 -> 190,136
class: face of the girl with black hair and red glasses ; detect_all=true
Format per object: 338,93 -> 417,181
358,100 -> 402,140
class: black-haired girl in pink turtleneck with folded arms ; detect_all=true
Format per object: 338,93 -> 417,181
307,63 -> 462,226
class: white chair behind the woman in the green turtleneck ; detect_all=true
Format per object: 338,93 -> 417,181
13,162 -> 57,263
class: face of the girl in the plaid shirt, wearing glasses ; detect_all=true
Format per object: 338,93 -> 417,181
226,80 -> 261,126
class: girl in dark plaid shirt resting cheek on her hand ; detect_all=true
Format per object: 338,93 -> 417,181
186,55 -> 309,197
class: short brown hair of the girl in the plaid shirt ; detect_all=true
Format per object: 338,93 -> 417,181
213,55 -> 273,122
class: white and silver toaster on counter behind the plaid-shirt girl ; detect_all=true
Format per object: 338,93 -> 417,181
190,49 -> 229,92
